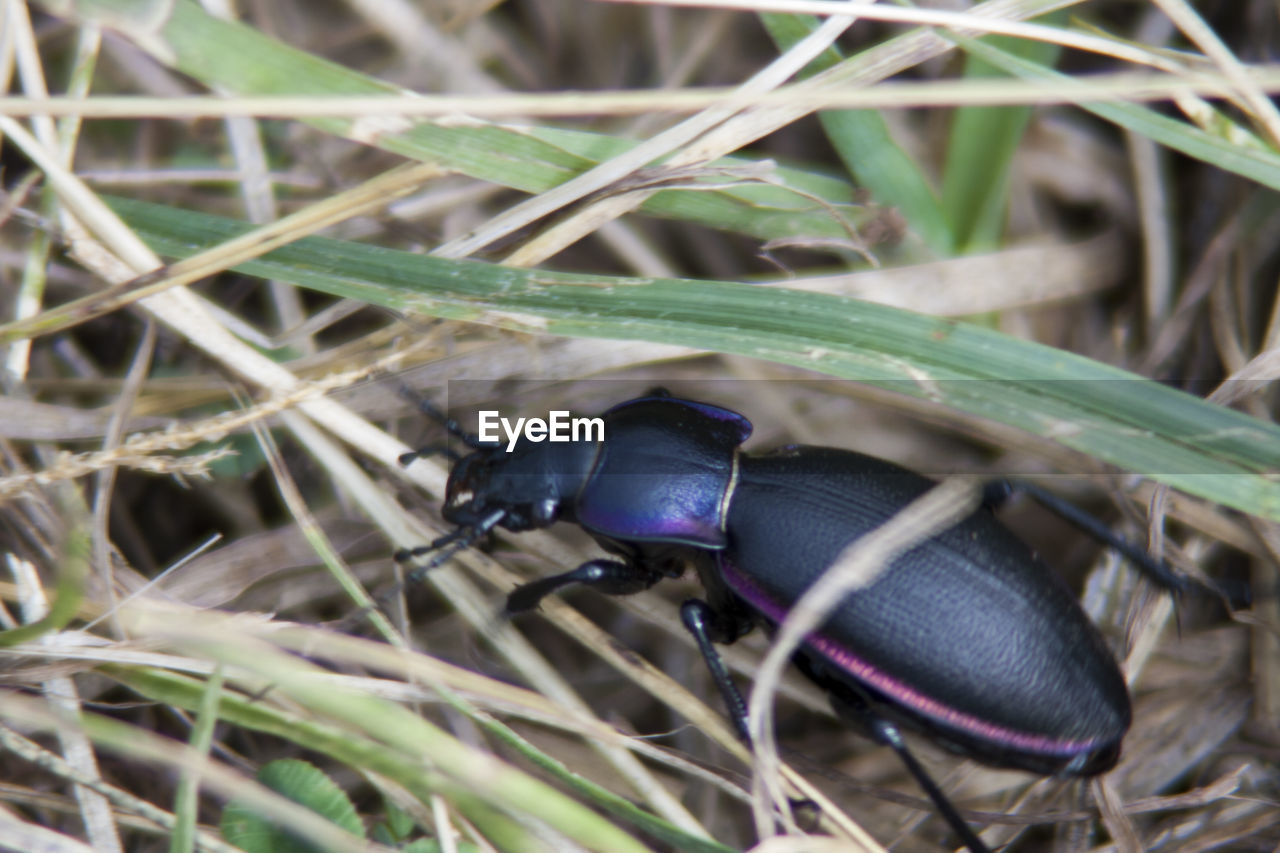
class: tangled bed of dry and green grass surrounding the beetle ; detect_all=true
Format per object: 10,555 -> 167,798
0,0 -> 1280,852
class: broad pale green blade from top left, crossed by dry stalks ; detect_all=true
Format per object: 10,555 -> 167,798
52,0 -> 870,241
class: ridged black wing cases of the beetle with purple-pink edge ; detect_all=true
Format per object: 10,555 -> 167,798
719,447 -> 1130,774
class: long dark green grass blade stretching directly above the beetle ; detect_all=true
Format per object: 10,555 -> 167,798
113,200 -> 1280,520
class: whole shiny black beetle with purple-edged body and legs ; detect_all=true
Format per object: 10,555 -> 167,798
397,389 -> 1183,853
